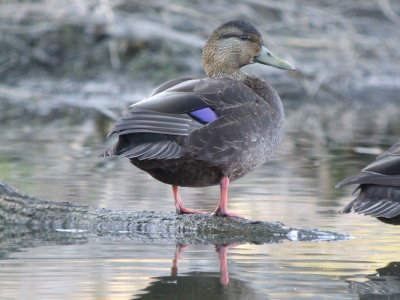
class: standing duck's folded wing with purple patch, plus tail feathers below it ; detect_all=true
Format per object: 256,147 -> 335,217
102,78 -> 253,160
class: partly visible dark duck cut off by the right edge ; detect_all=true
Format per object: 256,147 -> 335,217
336,140 -> 400,225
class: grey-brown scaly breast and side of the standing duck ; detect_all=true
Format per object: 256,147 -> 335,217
187,78 -> 284,180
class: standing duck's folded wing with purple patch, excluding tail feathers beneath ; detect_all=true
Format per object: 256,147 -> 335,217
110,78 -> 258,136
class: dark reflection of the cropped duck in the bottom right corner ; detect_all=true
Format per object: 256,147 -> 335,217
346,262 -> 400,300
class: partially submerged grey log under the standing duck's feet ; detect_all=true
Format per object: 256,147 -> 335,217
0,180 -> 350,244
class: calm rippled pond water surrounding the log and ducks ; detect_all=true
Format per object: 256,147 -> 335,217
0,113 -> 400,299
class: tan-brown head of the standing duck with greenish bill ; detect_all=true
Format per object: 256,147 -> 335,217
203,20 -> 295,79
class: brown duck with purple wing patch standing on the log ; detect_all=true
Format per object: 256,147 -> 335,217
101,20 -> 295,218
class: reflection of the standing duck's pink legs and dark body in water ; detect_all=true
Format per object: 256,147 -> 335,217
132,244 -> 267,300
